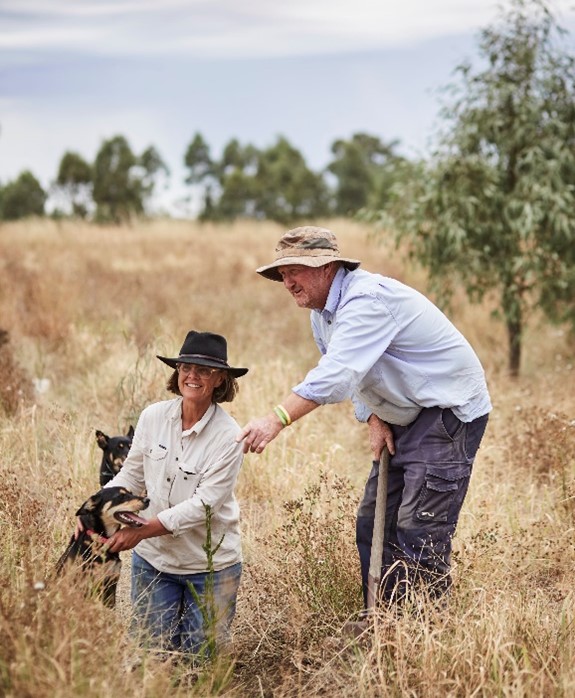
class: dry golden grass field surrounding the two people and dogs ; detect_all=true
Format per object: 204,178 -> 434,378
0,221 -> 575,698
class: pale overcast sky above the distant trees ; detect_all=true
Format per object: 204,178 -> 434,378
0,0 -> 575,210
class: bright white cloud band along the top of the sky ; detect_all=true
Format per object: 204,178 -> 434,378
0,0 -> 520,59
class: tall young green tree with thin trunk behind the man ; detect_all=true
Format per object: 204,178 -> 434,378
383,0 -> 575,376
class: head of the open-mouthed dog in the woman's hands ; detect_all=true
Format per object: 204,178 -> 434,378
76,487 -> 150,538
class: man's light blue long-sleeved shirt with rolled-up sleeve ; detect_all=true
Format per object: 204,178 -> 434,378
293,268 -> 491,426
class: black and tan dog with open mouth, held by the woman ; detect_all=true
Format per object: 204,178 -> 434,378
56,487 -> 149,608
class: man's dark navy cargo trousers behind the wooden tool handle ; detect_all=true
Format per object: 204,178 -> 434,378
356,407 -> 488,603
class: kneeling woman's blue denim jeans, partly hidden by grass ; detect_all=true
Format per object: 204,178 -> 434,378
131,552 -> 242,654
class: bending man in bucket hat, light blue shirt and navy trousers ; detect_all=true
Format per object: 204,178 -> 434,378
238,226 -> 491,602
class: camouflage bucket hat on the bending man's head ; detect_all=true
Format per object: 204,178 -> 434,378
256,225 -> 361,281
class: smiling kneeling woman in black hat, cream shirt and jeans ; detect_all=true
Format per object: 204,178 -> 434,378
107,330 -> 248,654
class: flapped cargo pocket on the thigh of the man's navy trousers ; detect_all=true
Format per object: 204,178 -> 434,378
415,464 -> 471,523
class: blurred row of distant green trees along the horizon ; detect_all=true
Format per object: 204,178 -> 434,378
0,132 -> 407,224
